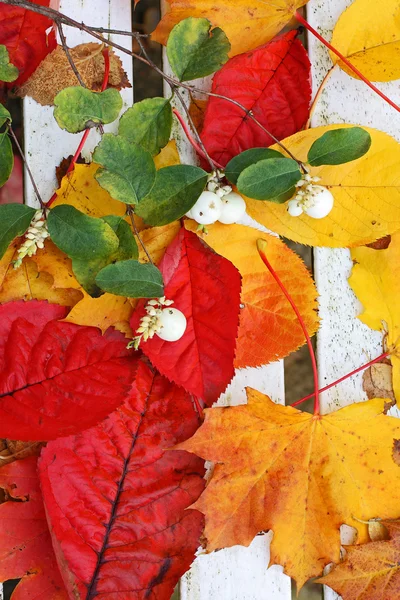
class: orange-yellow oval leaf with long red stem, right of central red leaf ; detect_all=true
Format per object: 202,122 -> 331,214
186,221 -> 318,368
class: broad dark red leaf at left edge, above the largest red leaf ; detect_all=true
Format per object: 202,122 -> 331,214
0,300 -> 137,441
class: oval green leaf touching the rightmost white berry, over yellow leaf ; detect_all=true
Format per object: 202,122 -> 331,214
238,158 -> 301,204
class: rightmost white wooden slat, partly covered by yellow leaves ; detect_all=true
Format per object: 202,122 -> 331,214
307,0 -> 400,600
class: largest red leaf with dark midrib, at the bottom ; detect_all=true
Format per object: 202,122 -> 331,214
39,363 -> 204,600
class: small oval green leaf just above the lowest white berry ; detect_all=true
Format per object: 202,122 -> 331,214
96,260 -> 164,298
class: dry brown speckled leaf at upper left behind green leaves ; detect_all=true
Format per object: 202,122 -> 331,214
18,43 -> 131,106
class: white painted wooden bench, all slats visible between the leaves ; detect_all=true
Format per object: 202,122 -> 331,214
0,0 -> 400,600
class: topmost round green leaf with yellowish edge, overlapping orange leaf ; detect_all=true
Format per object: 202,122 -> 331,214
167,17 -> 231,81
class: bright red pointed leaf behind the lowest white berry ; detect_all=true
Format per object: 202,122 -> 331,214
131,229 -> 241,405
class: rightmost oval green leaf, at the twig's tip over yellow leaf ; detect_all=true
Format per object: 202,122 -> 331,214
308,127 -> 372,167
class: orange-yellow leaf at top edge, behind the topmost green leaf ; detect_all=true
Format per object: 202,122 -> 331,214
152,0 -> 307,56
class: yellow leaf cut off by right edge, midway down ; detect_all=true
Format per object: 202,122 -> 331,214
349,233 -> 400,406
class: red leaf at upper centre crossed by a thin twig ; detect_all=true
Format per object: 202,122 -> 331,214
201,30 -> 311,166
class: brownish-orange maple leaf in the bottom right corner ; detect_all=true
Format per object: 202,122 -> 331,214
318,521 -> 400,600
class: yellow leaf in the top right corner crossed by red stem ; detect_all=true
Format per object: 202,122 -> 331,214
331,0 -> 400,81
